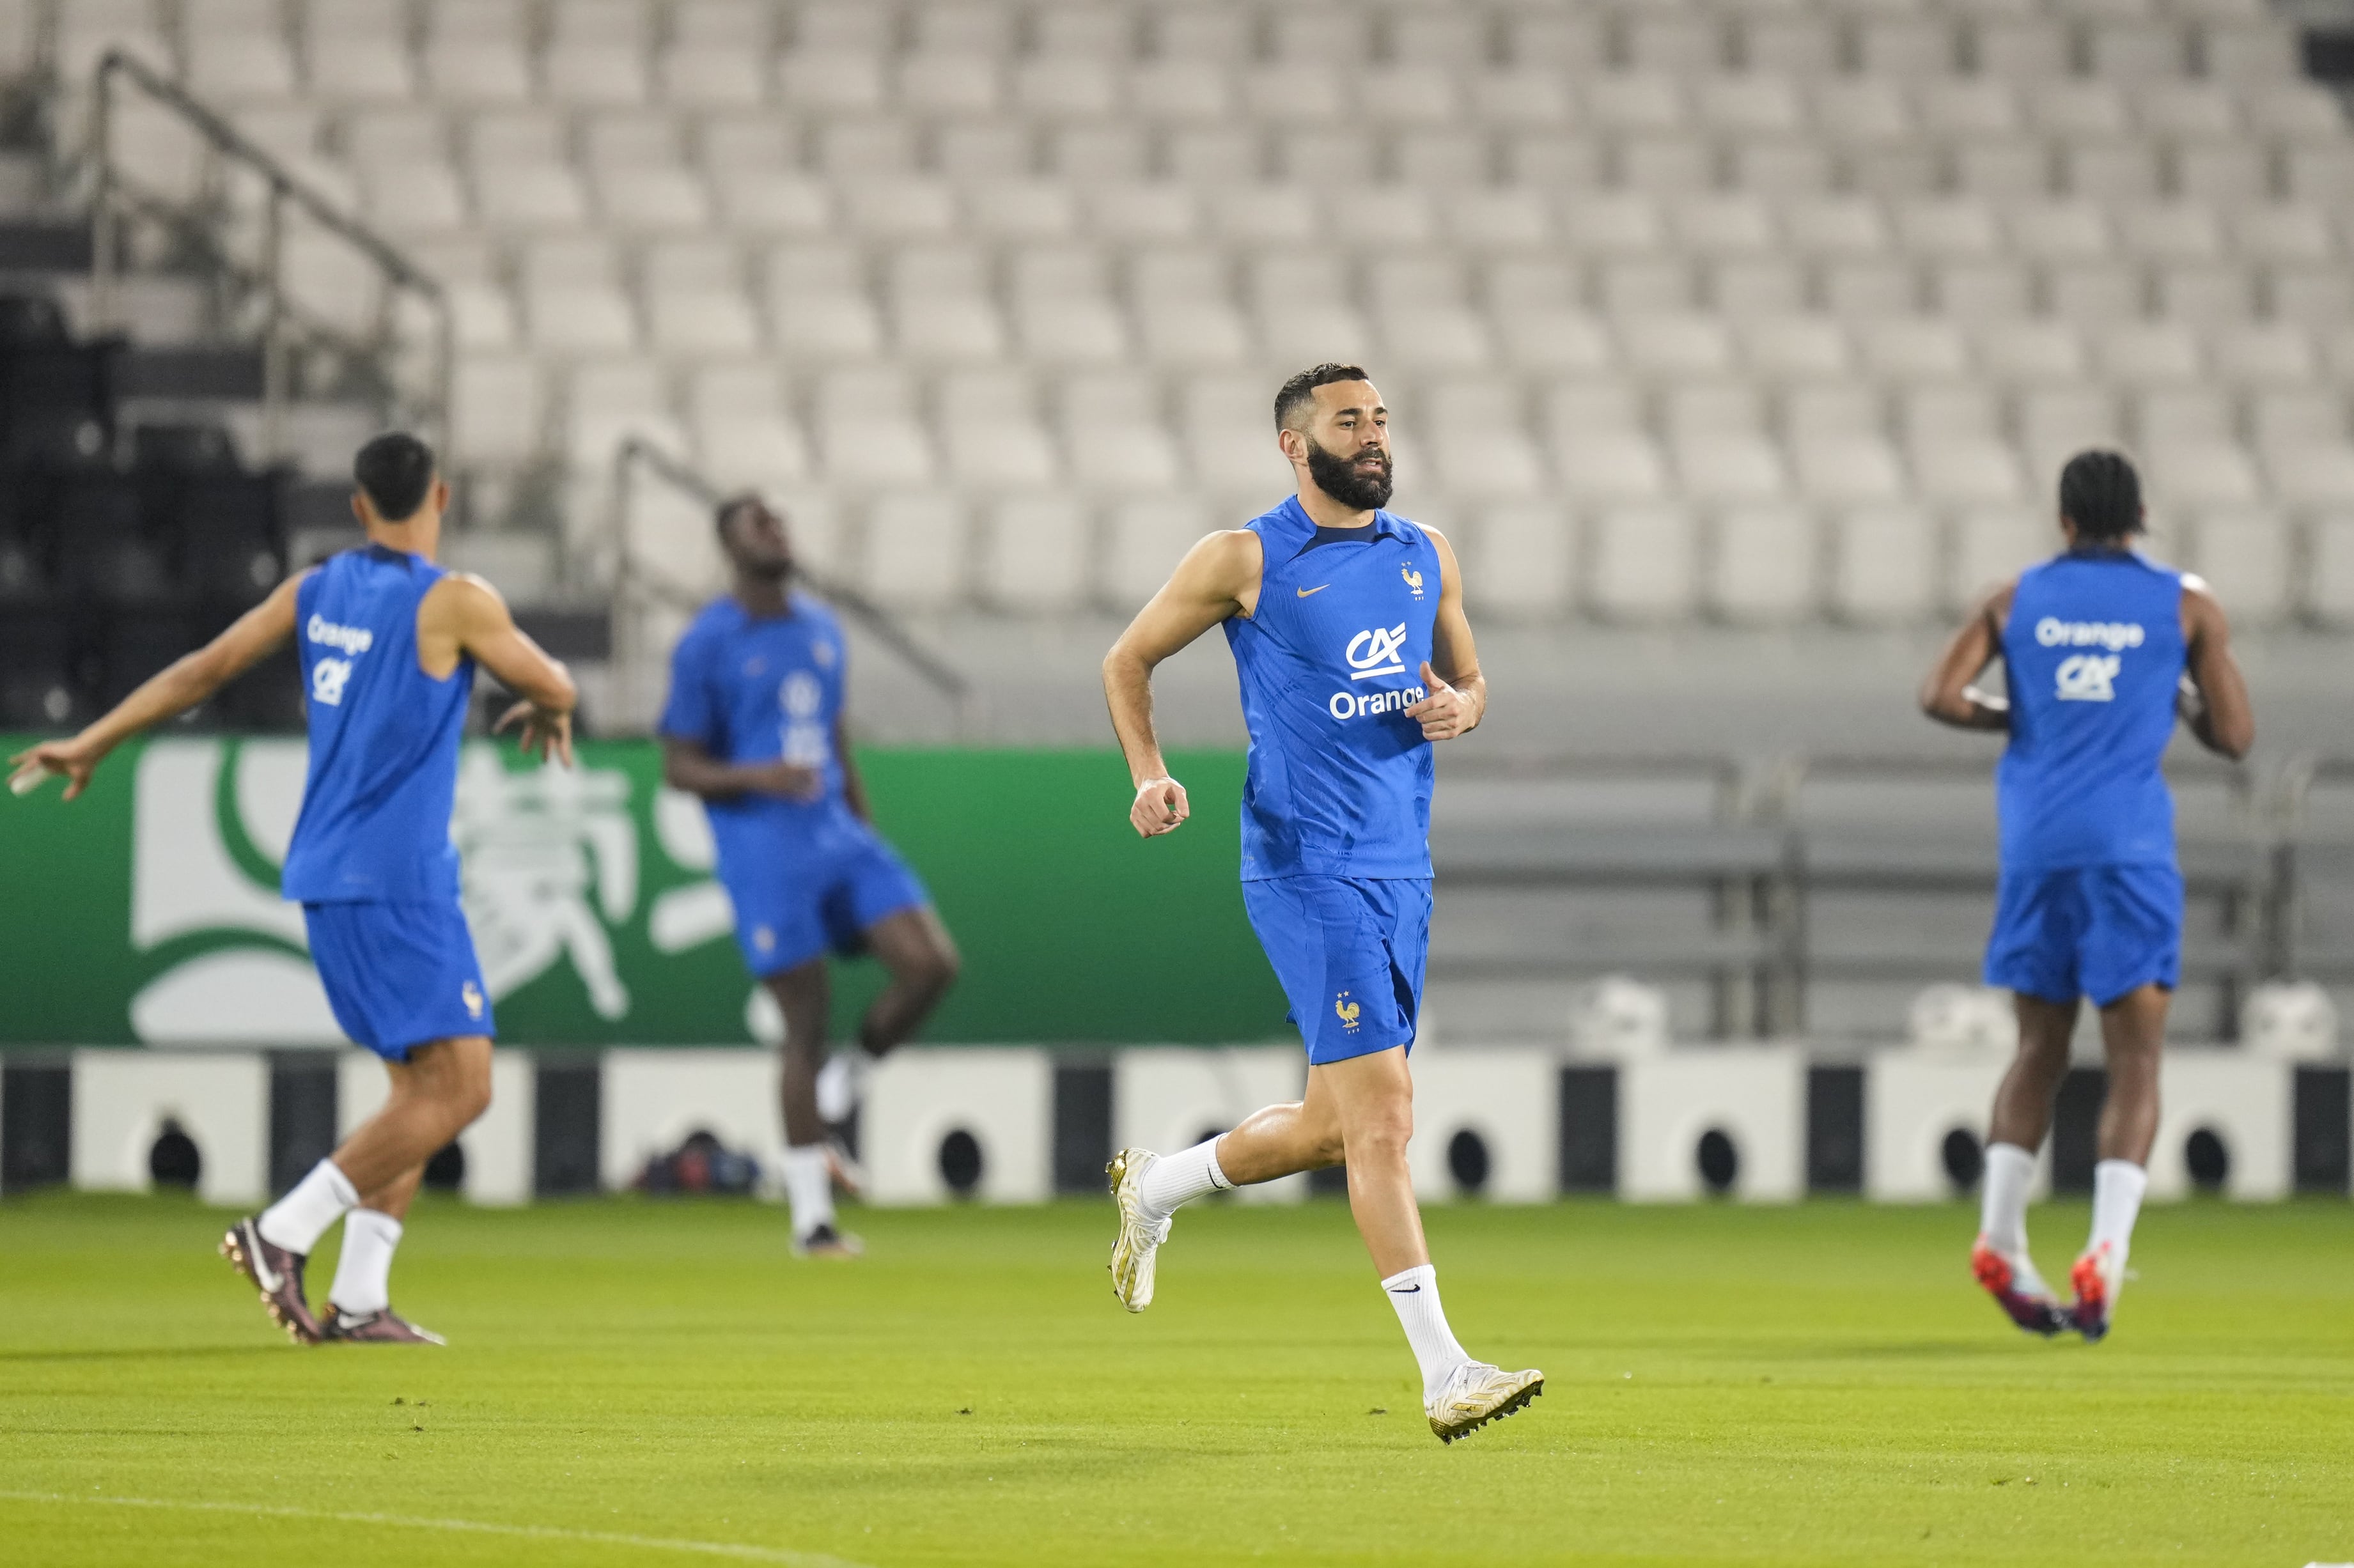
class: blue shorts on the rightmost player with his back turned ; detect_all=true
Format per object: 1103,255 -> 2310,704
1987,866 -> 2182,1007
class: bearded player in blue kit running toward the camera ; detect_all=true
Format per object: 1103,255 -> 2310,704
1104,365 -> 1544,1443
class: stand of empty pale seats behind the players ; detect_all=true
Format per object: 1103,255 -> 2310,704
0,0 -> 2354,621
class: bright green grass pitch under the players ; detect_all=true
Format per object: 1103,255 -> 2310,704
0,1196 -> 2354,1568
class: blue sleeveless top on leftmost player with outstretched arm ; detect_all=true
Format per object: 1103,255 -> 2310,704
280,544 -> 473,904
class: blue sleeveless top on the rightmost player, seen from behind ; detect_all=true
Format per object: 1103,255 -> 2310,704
1994,551 -> 2185,871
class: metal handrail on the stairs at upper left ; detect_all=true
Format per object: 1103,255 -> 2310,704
92,49 -> 456,457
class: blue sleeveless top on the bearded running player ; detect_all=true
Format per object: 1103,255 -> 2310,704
1226,497 -> 1438,881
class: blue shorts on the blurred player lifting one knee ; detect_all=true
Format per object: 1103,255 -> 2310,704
721,824 -> 930,979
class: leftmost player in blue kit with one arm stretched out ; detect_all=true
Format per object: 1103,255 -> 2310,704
14,435 -> 574,1344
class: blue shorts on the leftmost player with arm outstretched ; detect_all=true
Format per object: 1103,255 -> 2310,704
301,899 -> 499,1062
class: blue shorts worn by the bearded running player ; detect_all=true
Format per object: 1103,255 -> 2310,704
1243,876 -> 1431,1064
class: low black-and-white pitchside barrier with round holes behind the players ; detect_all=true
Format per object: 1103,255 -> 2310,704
0,1045 -> 2354,1203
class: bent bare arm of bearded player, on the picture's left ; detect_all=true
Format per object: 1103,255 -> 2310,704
1104,527 -> 1264,838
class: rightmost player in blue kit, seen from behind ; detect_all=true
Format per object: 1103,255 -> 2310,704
1921,452 -> 2255,1340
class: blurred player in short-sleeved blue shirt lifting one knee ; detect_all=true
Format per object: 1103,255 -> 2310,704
662,497 -> 956,1257
